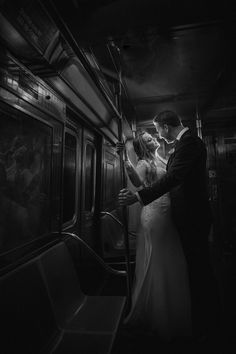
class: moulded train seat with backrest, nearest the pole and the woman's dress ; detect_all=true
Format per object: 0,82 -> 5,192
39,242 -> 125,354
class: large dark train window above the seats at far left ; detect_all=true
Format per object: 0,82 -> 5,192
0,111 -> 52,252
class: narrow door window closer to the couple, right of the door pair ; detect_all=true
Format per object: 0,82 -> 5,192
84,143 -> 95,212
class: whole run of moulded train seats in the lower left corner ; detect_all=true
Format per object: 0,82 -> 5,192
0,241 -> 126,354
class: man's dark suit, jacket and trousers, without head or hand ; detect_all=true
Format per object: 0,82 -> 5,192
138,130 -> 219,338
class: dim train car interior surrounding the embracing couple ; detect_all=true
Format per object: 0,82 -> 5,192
0,0 -> 236,354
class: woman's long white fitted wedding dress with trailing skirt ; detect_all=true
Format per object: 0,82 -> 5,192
125,160 -> 191,340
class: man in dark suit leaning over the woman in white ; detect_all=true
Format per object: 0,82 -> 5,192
119,111 -> 219,337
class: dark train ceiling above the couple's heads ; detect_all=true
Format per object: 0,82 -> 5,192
47,0 -> 236,126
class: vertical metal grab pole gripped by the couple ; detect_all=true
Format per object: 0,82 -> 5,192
116,71 -> 132,312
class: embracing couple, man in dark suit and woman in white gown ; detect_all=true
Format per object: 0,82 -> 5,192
119,111 -> 219,340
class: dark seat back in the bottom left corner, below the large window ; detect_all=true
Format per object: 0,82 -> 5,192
0,258 -> 58,354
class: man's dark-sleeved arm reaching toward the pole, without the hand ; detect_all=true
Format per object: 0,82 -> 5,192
137,136 -> 205,205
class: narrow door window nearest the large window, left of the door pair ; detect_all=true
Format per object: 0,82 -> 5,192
63,132 -> 77,223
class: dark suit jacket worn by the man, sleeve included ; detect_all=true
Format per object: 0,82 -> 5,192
139,130 -> 211,252
